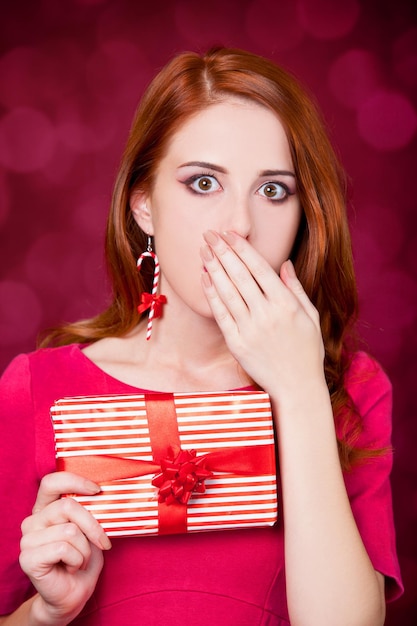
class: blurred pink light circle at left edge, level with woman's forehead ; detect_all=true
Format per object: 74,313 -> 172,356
0,107 -> 56,173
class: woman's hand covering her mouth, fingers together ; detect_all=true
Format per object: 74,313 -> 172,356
201,231 -> 324,395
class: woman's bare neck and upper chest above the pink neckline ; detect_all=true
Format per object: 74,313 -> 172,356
85,302 -> 252,391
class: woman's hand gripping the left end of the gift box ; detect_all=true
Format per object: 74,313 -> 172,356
20,472 -> 111,624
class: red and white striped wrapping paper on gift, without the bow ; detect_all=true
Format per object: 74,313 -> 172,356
51,391 -> 277,536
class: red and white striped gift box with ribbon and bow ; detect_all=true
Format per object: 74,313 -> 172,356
51,391 -> 277,536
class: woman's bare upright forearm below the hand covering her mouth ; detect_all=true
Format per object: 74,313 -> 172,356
273,381 -> 385,626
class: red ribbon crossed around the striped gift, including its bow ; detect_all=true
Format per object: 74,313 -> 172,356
57,393 -> 275,534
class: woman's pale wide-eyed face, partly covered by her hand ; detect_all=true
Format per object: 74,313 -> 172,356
131,98 -> 301,316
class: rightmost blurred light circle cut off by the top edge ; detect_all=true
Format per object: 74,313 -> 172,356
297,0 -> 361,39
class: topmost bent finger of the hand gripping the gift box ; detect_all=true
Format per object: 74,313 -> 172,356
32,472 -> 100,513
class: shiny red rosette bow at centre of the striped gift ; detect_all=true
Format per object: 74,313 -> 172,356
152,449 -> 213,504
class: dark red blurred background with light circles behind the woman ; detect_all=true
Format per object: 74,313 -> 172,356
0,0 -> 417,626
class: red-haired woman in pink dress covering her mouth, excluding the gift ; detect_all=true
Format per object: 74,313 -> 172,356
0,49 -> 401,626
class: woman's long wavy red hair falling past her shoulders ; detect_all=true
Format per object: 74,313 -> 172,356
42,48 -> 373,469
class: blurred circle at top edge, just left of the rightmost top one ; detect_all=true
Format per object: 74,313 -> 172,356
246,0 -> 304,51
